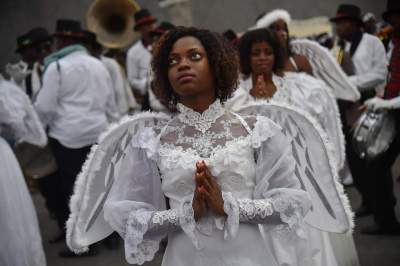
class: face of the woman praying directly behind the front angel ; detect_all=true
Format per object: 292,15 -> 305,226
250,42 -> 275,76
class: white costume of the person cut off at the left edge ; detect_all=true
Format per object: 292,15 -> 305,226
0,77 -> 47,266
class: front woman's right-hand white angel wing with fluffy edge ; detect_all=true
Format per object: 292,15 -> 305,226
239,102 -> 353,233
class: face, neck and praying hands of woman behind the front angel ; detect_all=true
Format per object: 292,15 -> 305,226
250,42 -> 277,98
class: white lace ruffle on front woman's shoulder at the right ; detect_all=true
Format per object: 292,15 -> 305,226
251,116 -> 281,149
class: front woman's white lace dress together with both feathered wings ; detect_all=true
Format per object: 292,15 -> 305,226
67,100 -> 350,266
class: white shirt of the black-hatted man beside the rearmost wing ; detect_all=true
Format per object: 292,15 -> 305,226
350,33 -> 388,91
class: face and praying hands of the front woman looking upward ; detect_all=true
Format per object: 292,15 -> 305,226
168,36 -> 226,221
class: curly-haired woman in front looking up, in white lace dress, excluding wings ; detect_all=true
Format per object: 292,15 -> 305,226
98,27 -> 310,266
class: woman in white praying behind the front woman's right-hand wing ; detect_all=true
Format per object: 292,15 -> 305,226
239,29 -> 358,266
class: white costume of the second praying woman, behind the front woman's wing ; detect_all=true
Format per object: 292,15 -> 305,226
241,75 -> 359,266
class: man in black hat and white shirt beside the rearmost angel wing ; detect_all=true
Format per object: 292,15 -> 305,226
330,4 -> 387,221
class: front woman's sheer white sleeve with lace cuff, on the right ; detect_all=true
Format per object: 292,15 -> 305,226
223,117 -> 311,237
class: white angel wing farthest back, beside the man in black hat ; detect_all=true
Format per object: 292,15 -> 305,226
290,39 -> 360,102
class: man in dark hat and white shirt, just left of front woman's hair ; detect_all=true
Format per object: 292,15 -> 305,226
126,8 -> 157,110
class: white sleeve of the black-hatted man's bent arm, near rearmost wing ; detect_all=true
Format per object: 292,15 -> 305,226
349,39 -> 388,91
